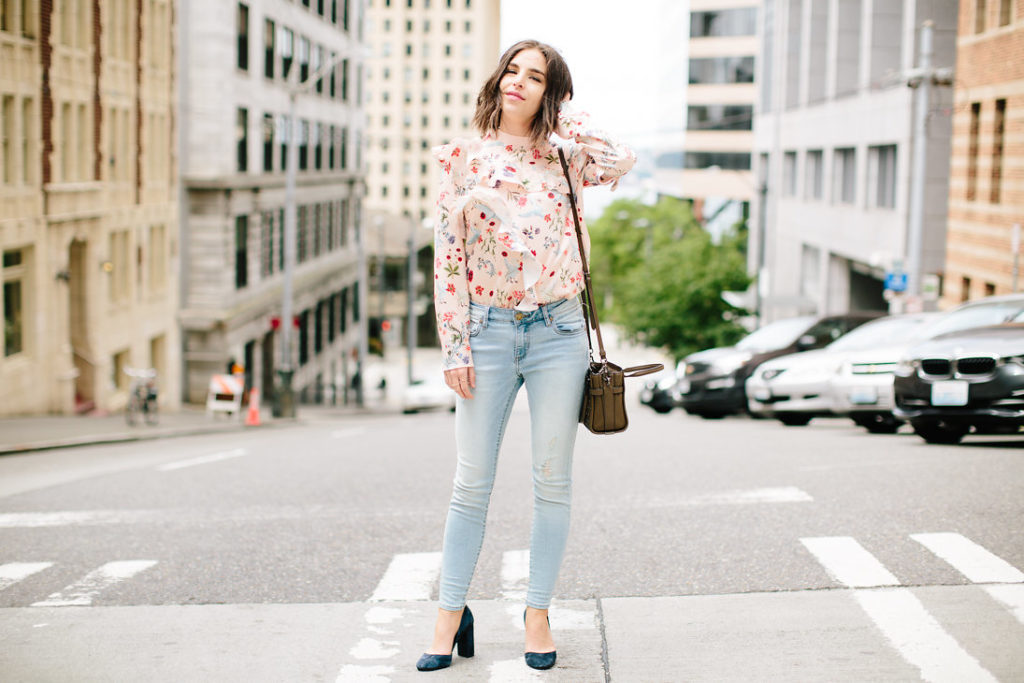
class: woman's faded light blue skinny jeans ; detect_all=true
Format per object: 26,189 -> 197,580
439,298 -> 590,611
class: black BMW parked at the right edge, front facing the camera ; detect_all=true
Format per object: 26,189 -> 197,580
893,323 -> 1024,443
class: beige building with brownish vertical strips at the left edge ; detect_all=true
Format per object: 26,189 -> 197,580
0,0 -> 180,416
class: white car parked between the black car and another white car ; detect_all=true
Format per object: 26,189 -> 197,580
746,313 -> 929,427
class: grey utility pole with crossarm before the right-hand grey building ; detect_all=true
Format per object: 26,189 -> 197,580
905,19 -> 953,305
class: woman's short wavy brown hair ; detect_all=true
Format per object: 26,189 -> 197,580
473,40 -> 572,143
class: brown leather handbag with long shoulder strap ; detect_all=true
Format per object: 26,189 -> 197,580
558,147 -> 665,434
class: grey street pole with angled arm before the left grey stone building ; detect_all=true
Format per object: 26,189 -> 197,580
278,53 -> 352,418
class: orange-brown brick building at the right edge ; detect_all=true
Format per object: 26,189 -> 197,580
943,0 -> 1024,305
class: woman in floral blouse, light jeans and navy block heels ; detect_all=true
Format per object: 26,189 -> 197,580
417,40 -> 635,671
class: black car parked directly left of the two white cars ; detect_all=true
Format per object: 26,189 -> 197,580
677,311 -> 884,418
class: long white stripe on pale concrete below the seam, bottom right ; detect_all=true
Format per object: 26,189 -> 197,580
853,588 -> 996,683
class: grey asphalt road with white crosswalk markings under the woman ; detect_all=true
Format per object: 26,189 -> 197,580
0,400 -> 1024,681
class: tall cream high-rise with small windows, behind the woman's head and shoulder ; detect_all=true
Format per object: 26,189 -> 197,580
366,0 -> 501,348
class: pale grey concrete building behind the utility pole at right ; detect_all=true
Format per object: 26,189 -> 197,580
750,0 -> 957,321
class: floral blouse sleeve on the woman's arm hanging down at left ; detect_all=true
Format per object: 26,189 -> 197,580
434,143 -> 473,370
